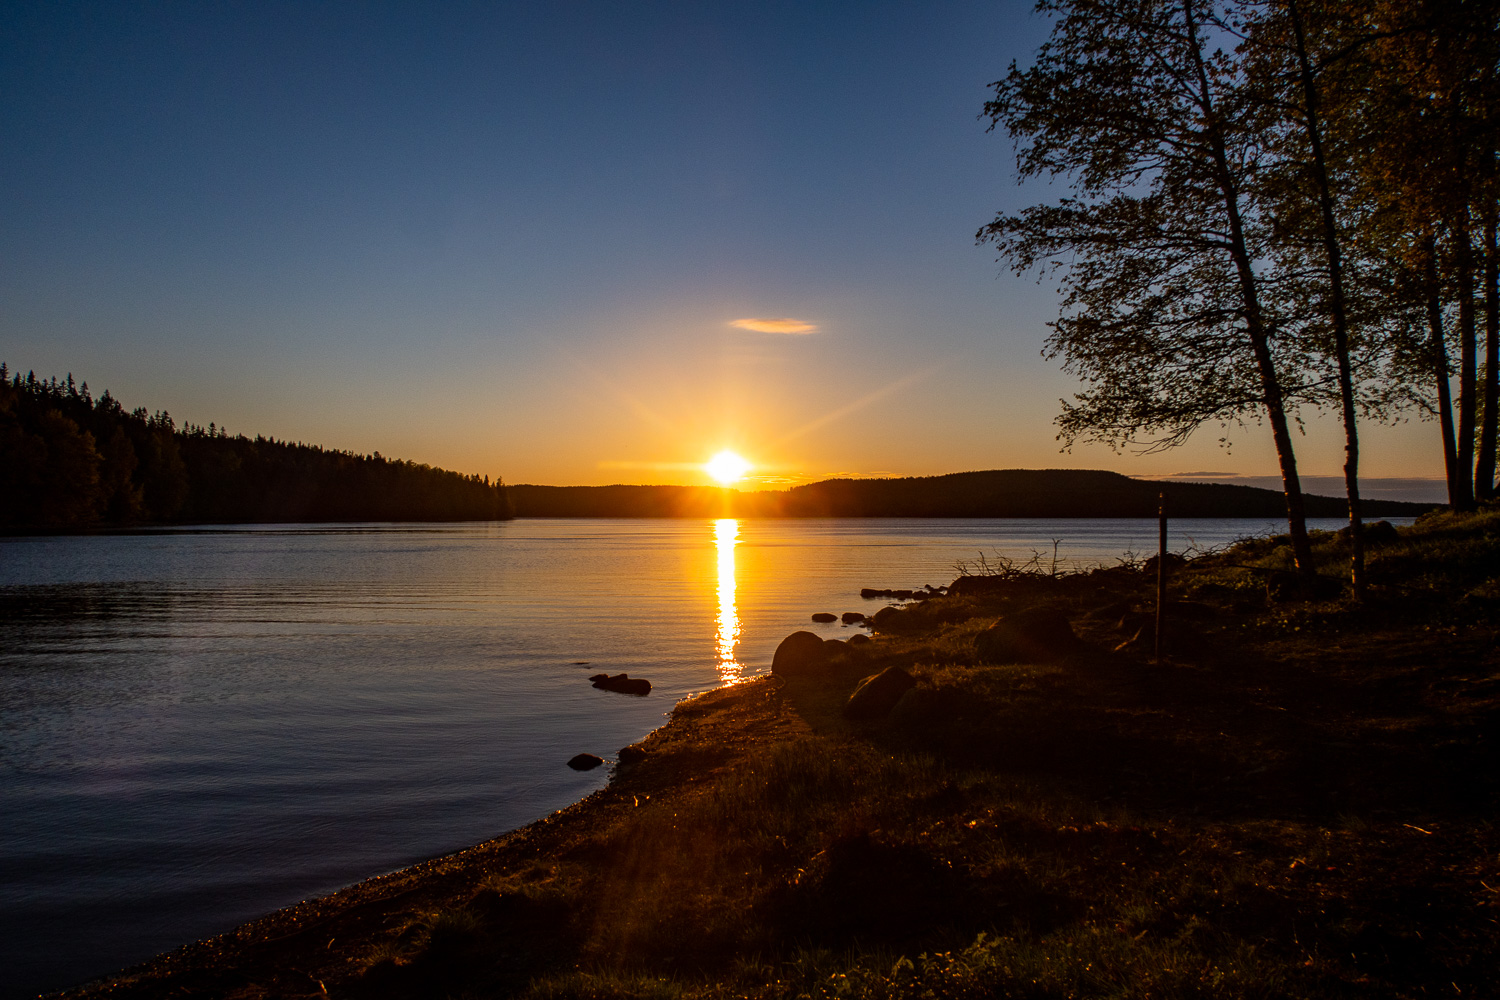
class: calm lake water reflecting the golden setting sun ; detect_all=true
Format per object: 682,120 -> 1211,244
0,520 -> 1362,997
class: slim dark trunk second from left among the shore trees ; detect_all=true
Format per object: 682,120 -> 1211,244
1287,0 -> 1365,600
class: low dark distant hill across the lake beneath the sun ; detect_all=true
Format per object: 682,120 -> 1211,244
507,469 -> 1433,517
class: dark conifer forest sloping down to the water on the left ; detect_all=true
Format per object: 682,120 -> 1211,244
0,363 -> 512,529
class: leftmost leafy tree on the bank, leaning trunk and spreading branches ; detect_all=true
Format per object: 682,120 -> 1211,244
978,0 -> 1317,574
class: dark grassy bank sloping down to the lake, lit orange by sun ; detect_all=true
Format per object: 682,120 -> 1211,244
64,511 -> 1500,999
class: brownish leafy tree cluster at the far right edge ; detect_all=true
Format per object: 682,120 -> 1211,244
1344,0 -> 1500,508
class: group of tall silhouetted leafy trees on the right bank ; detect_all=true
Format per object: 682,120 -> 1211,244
978,0 -> 1500,595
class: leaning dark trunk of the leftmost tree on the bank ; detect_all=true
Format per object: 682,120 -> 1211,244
1182,0 -> 1313,577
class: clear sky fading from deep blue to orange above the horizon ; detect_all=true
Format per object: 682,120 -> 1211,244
0,1 -> 1442,484
